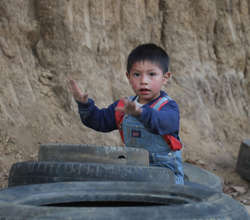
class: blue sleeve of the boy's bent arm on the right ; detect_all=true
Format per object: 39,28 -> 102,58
137,101 -> 180,135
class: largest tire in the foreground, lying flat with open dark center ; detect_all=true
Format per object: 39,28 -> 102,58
0,182 -> 250,220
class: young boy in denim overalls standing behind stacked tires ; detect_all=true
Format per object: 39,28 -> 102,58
70,44 -> 184,184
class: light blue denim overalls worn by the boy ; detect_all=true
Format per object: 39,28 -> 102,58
122,96 -> 184,184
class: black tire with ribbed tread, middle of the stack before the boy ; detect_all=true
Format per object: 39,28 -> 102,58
8,161 -> 175,186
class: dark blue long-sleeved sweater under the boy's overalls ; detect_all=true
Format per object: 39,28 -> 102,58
77,91 -> 180,139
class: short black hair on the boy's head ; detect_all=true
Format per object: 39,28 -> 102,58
127,43 -> 169,73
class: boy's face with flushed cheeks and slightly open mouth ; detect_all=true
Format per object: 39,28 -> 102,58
126,61 -> 171,104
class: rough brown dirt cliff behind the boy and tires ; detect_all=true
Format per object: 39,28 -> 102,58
0,0 -> 250,192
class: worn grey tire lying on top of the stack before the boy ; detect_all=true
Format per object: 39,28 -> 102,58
38,143 -> 149,166
